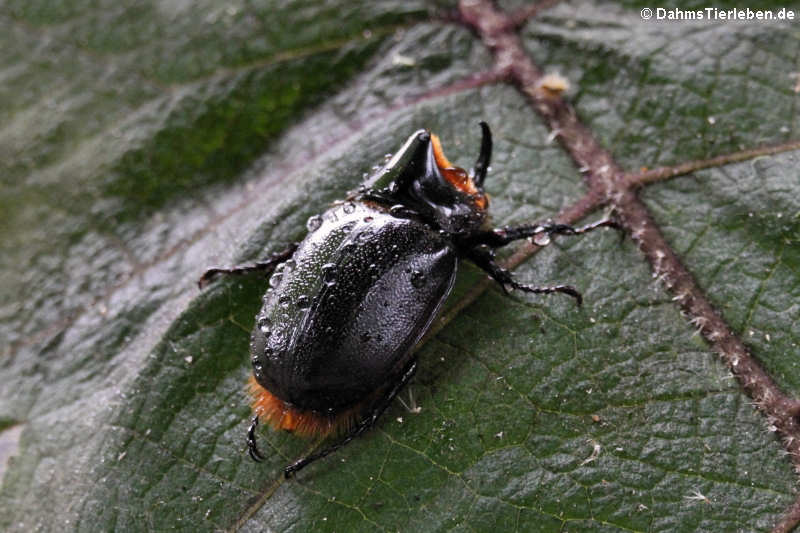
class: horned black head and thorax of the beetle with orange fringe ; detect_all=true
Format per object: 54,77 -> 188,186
365,122 -> 492,233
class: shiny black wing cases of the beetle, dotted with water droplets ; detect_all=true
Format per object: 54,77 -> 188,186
251,201 -> 458,415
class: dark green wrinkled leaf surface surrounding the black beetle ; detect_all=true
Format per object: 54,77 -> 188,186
0,0 -> 800,532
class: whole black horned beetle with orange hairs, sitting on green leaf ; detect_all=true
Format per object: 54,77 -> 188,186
200,122 -> 616,478
